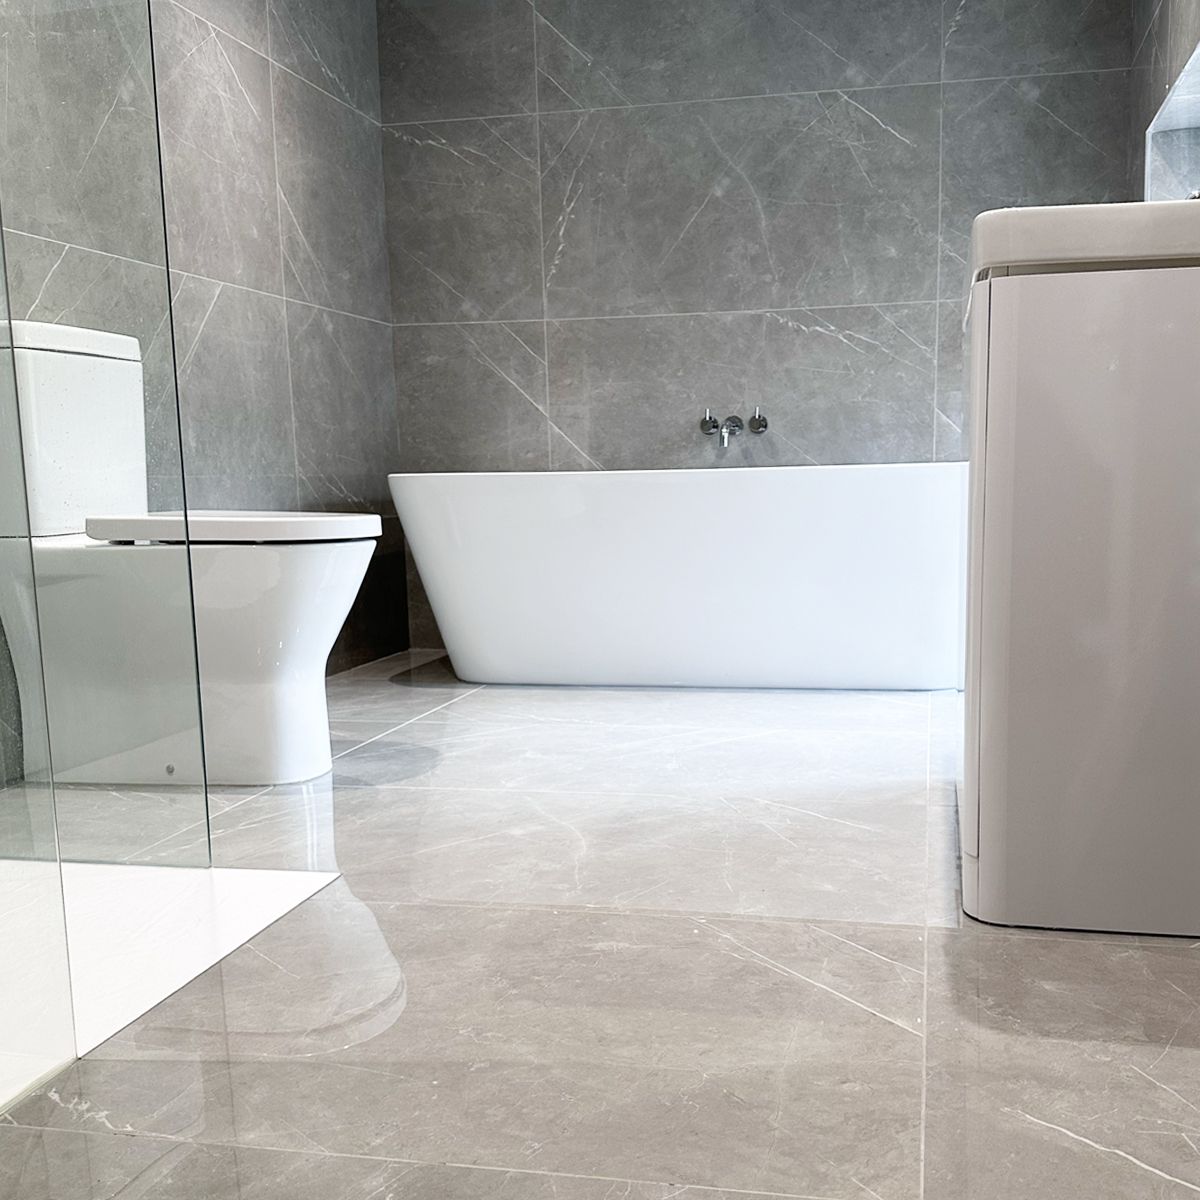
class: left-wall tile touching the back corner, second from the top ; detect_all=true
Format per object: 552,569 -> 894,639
271,67 -> 390,320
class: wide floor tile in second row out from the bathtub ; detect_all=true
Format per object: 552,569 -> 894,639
316,787 -> 926,925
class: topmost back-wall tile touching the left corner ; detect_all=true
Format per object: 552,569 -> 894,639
379,0 -> 535,124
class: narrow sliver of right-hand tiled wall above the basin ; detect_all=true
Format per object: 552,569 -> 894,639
1129,0 -> 1200,192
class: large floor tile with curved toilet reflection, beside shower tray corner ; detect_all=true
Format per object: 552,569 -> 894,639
11,895 -> 924,1200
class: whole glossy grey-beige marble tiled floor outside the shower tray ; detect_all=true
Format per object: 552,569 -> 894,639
0,656 -> 1200,1200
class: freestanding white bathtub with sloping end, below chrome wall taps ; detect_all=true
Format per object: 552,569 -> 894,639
389,463 -> 967,689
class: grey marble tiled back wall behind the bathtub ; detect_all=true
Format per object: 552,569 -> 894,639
379,0 -> 1133,482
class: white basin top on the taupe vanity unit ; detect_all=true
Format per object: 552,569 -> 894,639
971,200 -> 1200,283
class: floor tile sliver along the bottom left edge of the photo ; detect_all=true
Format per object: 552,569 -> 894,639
0,1127 -> 796,1200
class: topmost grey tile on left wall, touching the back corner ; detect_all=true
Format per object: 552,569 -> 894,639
268,0 -> 379,120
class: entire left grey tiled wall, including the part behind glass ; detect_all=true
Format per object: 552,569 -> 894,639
0,0 -> 407,666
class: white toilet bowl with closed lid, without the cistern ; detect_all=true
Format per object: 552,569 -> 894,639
34,512 -> 380,785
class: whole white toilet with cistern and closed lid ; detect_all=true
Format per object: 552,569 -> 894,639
0,322 -> 382,786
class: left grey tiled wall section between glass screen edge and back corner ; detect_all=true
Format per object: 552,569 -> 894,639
152,0 -> 407,667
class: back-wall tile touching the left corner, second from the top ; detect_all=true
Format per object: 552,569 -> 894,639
384,118 -> 542,322
